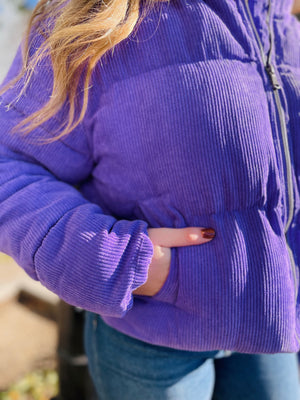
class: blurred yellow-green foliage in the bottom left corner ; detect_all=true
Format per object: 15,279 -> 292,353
0,371 -> 58,400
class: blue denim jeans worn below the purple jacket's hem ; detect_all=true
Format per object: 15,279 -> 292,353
85,312 -> 300,400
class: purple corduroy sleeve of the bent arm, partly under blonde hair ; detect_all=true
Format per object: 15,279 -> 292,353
0,47 -> 153,317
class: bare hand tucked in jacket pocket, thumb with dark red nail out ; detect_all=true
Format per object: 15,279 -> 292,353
133,227 -> 215,296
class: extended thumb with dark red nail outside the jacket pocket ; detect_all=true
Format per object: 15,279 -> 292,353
148,227 -> 215,247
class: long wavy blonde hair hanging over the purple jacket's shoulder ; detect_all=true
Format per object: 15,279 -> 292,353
1,0 -> 161,141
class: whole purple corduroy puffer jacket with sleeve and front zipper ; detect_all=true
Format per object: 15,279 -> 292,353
0,0 -> 300,353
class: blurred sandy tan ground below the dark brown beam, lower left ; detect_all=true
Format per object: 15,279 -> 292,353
0,302 -> 57,393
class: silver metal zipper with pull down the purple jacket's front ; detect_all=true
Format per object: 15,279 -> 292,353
245,0 -> 300,304
